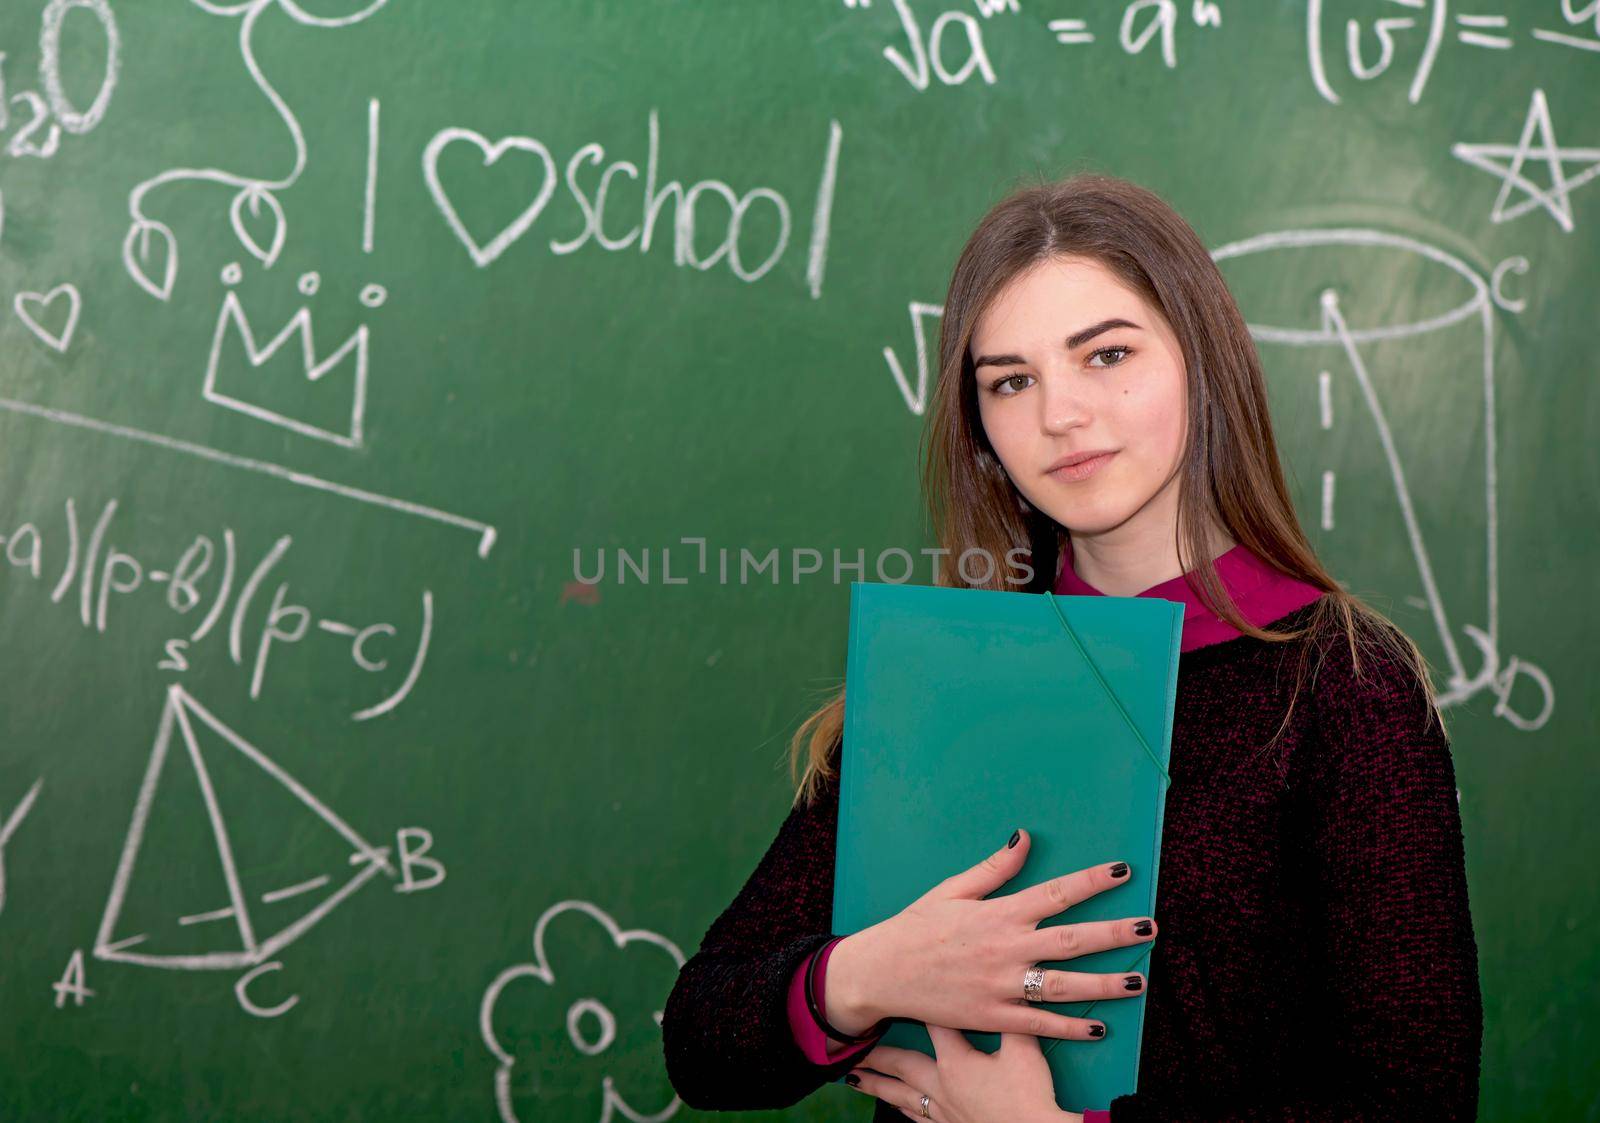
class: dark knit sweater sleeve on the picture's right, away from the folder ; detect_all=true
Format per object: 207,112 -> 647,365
1110,641 -> 1483,1123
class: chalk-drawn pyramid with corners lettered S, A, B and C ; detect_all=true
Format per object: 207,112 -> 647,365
94,683 -> 395,971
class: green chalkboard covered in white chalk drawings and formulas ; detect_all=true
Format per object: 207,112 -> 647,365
0,0 -> 1600,1121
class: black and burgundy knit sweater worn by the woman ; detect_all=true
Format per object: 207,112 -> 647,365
661,606 -> 1483,1123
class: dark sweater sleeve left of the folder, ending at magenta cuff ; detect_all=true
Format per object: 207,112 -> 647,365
661,750 -> 876,1112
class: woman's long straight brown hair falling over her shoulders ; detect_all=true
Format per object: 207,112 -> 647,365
789,173 -> 1443,801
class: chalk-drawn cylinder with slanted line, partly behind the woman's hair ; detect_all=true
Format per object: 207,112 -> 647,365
1213,229 -> 1549,723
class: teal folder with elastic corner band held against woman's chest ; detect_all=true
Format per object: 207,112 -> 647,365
834,581 -> 1184,1112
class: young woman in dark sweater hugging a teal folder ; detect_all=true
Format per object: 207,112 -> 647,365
661,174 -> 1483,1123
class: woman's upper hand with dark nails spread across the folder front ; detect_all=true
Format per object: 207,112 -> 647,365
826,830 -> 1155,1040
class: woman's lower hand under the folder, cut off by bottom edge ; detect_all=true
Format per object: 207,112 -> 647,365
851,1025 -> 1083,1123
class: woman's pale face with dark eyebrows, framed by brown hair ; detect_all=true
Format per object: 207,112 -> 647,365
971,258 -> 1189,541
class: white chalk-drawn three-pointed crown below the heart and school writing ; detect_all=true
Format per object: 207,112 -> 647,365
205,290 -> 368,448
